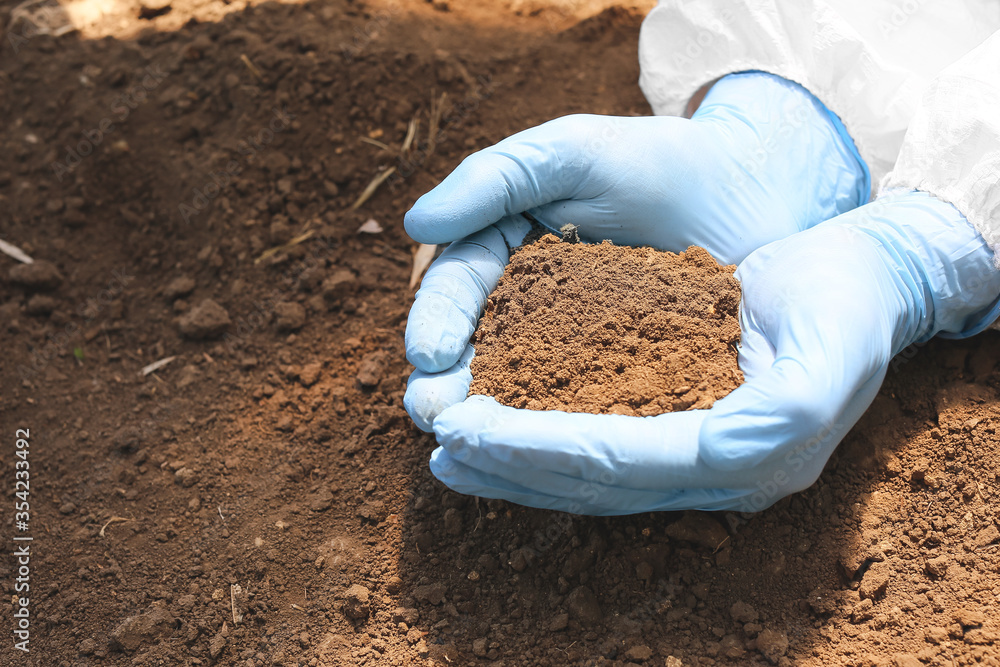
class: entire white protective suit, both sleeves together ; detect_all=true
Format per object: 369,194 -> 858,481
639,0 -> 1000,253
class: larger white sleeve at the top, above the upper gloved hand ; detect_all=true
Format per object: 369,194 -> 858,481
639,0 -> 1000,194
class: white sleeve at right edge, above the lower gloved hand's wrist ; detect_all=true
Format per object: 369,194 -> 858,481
881,32 -> 1000,264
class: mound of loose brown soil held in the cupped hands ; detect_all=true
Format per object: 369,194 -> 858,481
469,234 -> 743,416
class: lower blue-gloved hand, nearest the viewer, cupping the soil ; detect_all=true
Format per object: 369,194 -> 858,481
431,191 -> 1000,515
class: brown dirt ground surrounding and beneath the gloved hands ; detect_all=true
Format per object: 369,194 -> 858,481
0,0 -> 1000,667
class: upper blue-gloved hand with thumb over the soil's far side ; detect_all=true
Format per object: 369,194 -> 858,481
405,72 -> 870,430
